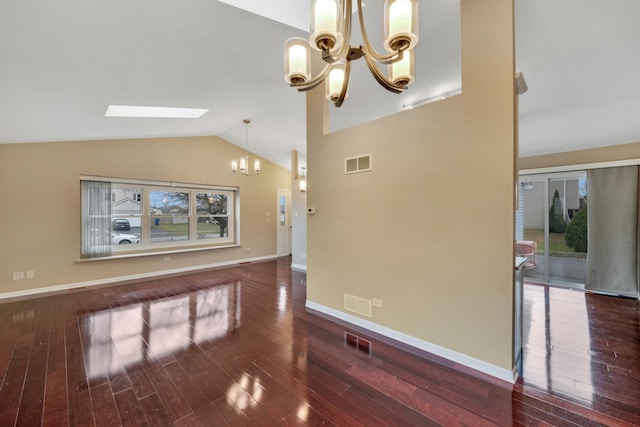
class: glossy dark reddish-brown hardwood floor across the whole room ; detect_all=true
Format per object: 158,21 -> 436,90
0,258 -> 640,427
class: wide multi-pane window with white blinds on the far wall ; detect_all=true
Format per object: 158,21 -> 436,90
81,179 -> 237,258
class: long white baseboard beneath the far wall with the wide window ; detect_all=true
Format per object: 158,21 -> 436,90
0,255 -> 277,301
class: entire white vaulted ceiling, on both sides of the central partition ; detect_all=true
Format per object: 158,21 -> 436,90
0,0 -> 640,168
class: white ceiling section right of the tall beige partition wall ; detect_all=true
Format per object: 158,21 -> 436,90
515,0 -> 640,157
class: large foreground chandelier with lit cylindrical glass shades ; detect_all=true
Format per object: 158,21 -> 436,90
284,0 -> 418,107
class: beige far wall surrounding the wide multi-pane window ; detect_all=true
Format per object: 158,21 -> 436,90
0,137 -> 291,294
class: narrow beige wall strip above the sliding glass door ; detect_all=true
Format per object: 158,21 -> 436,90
518,142 -> 640,170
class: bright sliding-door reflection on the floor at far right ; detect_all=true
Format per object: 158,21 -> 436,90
524,285 -> 594,403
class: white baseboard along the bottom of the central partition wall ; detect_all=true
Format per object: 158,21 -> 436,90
305,300 -> 517,384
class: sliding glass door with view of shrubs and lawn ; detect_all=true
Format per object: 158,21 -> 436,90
517,172 -> 587,288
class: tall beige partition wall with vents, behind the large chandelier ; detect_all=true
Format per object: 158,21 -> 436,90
307,0 -> 516,371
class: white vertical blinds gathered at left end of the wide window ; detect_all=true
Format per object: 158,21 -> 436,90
81,181 -> 111,258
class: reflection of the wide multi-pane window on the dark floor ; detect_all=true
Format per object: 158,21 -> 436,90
80,281 -> 241,379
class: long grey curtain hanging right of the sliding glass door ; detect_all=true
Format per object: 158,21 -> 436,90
585,166 -> 639,297
